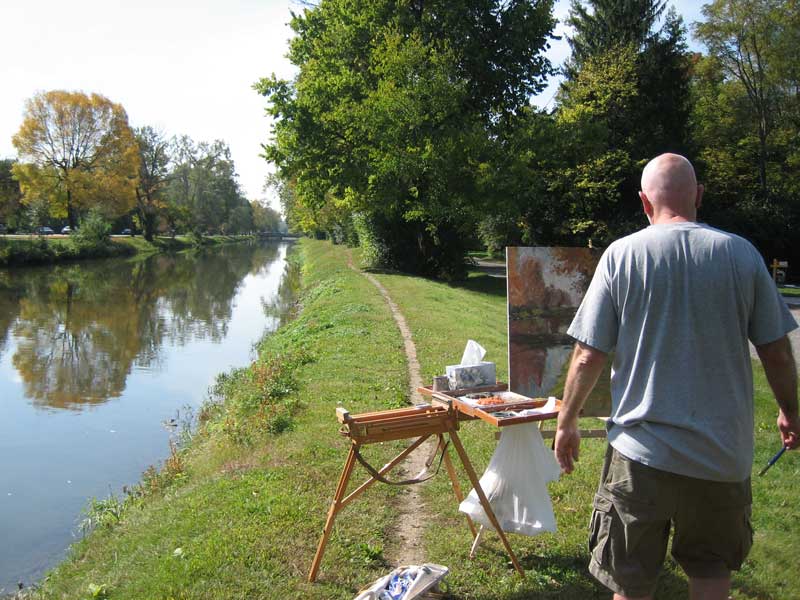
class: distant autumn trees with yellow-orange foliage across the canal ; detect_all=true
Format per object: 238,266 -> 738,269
0,90 -> 285,240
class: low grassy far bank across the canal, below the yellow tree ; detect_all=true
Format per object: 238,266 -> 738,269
0,235 -> 255,267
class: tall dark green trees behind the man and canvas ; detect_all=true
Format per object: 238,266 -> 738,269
256,0 -> 800,277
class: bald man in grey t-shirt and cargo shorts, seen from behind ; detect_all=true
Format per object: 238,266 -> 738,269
555,154 -> 800,600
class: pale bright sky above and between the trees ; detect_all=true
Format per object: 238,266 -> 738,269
0,0 -> 701,209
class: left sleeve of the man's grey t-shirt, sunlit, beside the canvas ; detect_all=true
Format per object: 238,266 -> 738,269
567,250 -> 619,353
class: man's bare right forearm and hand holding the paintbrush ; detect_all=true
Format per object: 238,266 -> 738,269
756,336 -> 800,449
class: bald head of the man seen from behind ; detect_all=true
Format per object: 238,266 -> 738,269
639,154 -> 703,223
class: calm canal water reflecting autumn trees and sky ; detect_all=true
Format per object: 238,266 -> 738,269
0,244 -> 289,595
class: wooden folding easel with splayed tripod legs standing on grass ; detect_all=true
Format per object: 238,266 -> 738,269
308,405 -> 525,582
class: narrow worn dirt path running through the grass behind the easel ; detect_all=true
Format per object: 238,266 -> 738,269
347,253 -> 433,565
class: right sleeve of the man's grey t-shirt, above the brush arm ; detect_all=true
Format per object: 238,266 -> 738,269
747,251 -> 797,346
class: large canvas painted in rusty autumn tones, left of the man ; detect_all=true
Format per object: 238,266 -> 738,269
506,247 -> 610,415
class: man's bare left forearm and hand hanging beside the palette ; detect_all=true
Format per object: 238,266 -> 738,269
555,342 -> 608,473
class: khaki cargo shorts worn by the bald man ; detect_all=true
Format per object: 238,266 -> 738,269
589,445 -> 753,596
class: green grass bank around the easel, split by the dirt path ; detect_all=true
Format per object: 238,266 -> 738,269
25,240 -> 800,600
